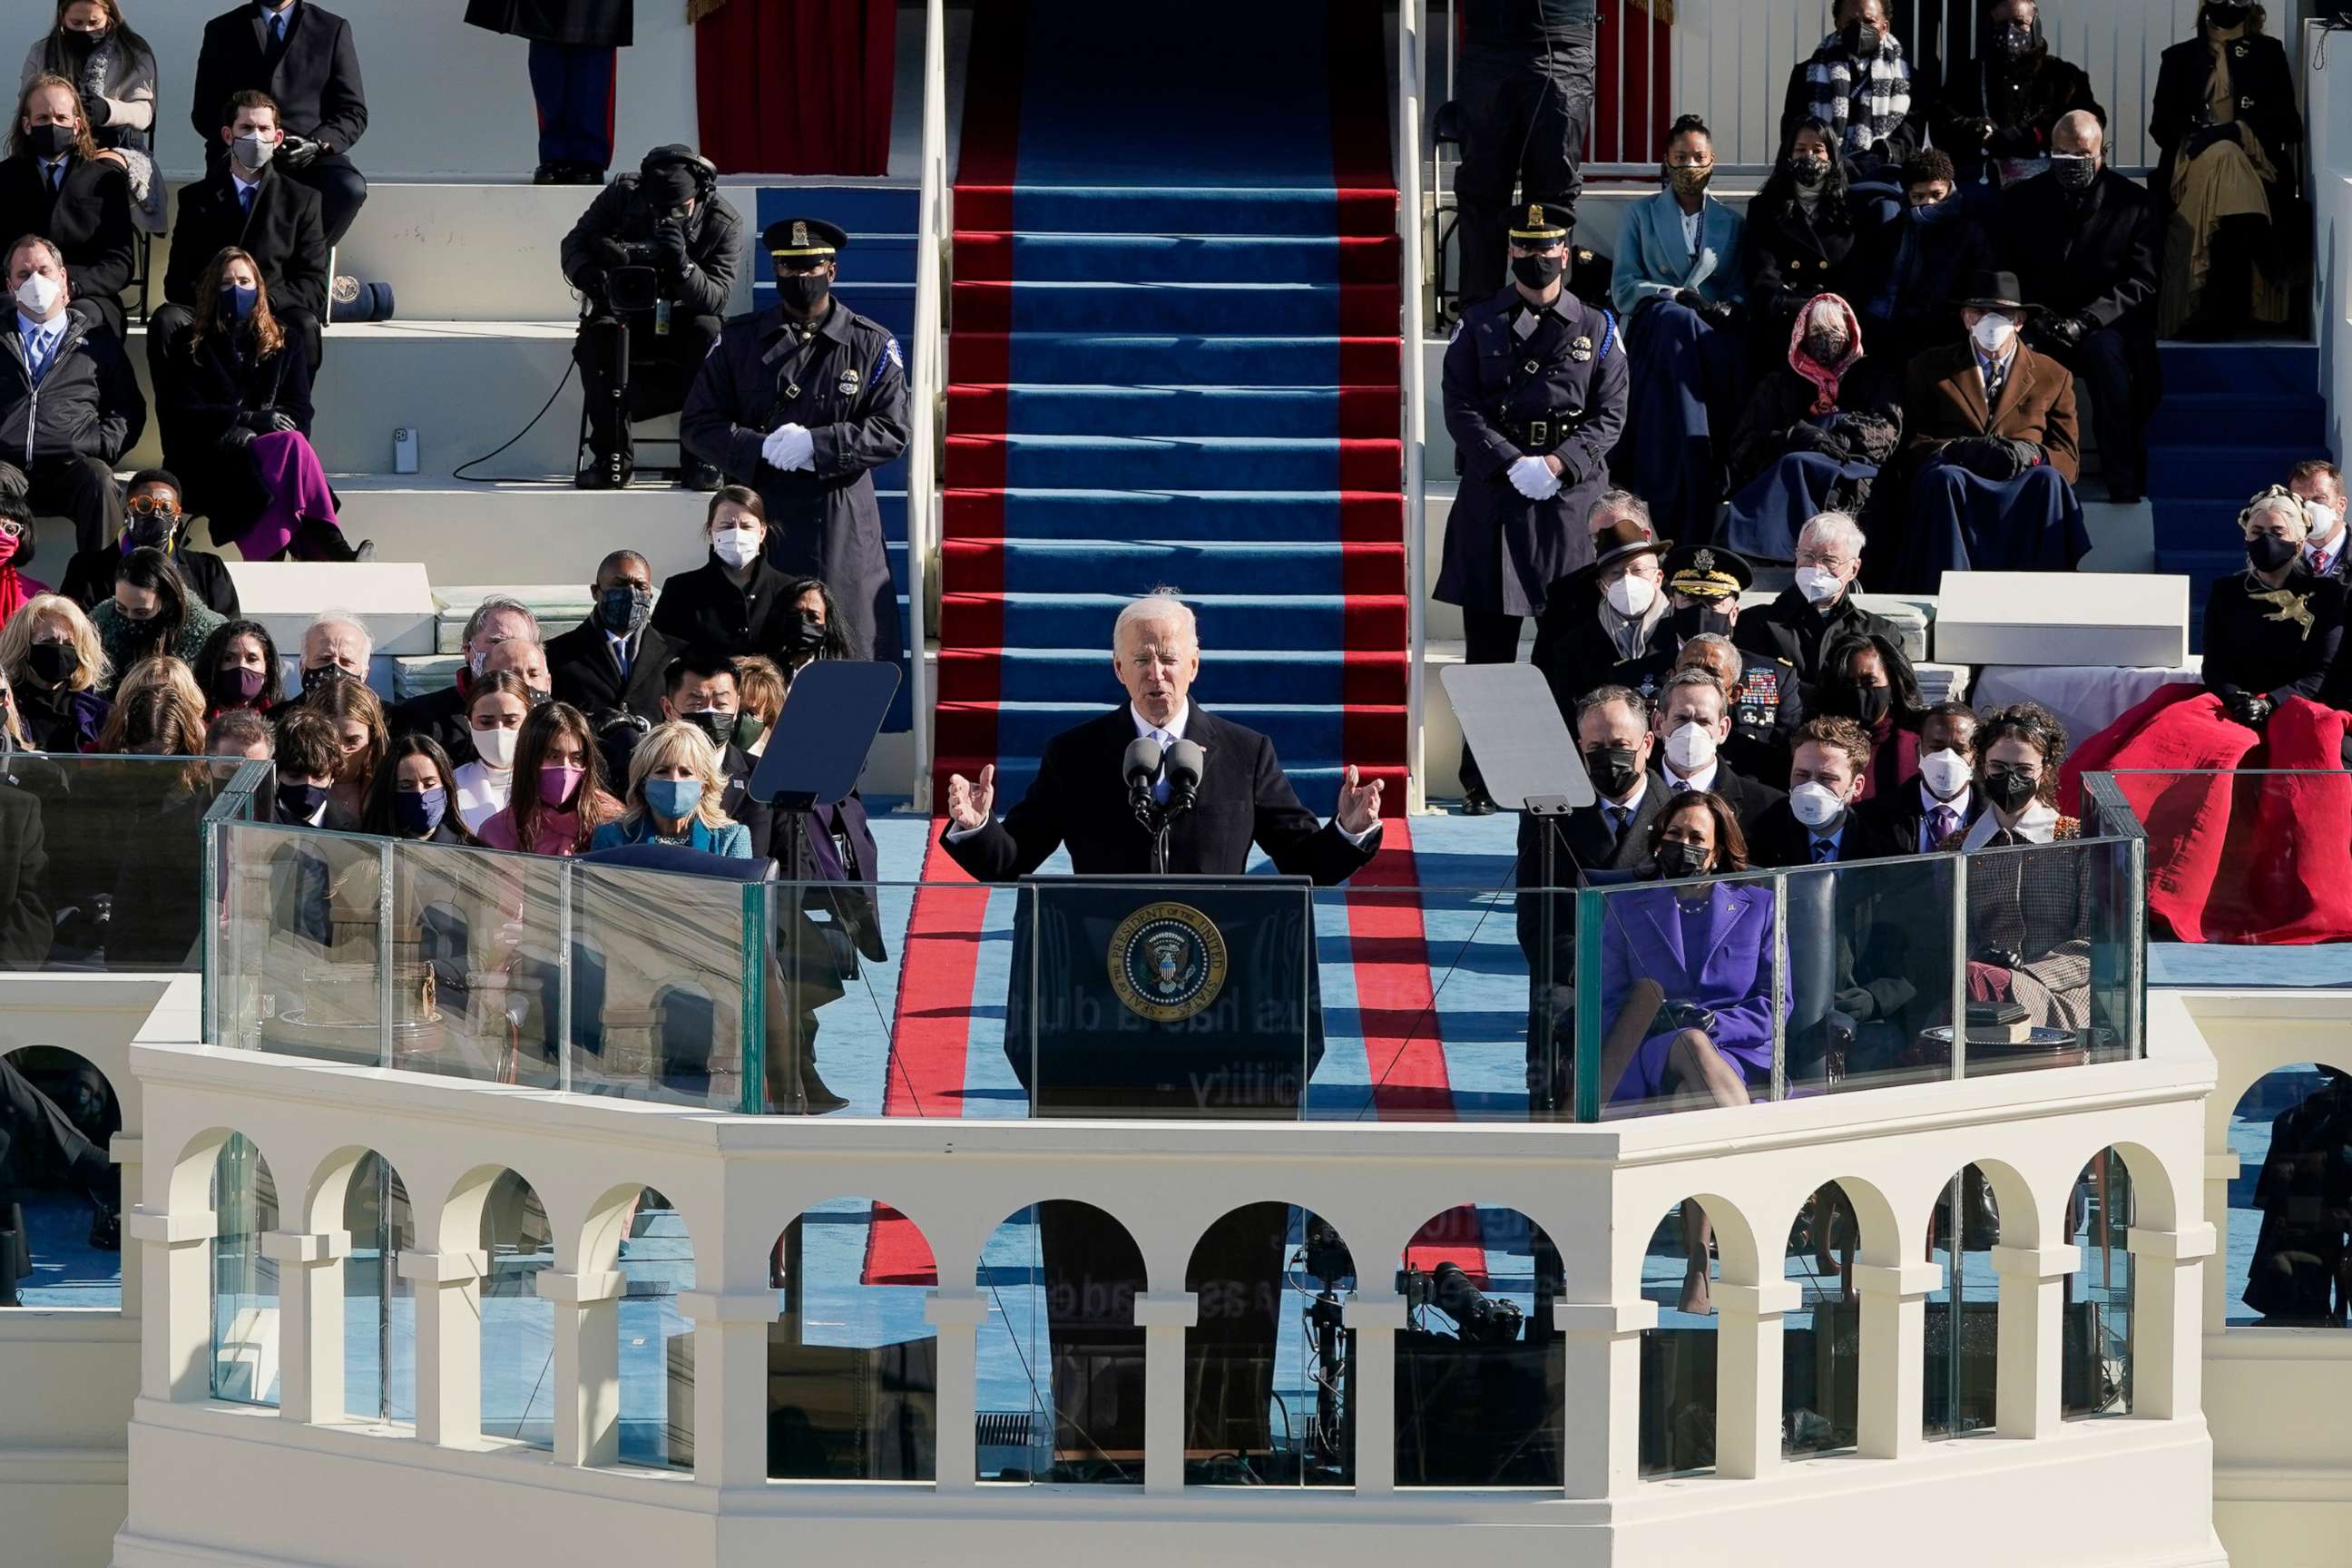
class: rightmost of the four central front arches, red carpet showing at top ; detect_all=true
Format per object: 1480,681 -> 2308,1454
1397,1206 -> 1569,1491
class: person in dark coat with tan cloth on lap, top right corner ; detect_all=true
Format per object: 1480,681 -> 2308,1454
2147,0 -> 2303,338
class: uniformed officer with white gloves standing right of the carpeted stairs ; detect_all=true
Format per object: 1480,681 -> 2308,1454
1437,204 -> 1625,816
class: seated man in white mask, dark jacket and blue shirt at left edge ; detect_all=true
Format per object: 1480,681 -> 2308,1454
0,235 -> 146,550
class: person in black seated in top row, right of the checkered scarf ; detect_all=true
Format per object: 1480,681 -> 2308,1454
1926,0 -> 2107,210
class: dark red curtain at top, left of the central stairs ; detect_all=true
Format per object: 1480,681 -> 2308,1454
694,0 -> 898,174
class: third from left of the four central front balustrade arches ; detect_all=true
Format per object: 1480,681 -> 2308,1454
1183,1203 -> 1355,1485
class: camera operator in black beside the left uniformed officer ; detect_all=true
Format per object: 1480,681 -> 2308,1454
562,143 -> 743,491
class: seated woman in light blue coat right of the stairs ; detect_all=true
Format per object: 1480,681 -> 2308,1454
1609,115 -> 1748,538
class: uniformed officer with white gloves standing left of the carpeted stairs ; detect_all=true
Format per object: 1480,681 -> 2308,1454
677,219 -> 906,663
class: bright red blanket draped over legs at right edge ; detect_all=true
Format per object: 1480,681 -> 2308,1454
2058,686 -> 2352,945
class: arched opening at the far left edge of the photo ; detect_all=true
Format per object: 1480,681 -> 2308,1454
0,1046 -> 122,1307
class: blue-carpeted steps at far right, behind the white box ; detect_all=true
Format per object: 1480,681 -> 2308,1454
2147,343 -> 2328,652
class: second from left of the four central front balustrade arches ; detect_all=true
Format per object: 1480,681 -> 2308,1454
974,1199 -> 1148,1485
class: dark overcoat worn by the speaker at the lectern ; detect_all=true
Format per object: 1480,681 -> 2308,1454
943,703 -> 1378,887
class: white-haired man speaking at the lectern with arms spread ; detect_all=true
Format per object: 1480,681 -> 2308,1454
941,590 -> 1383,884
